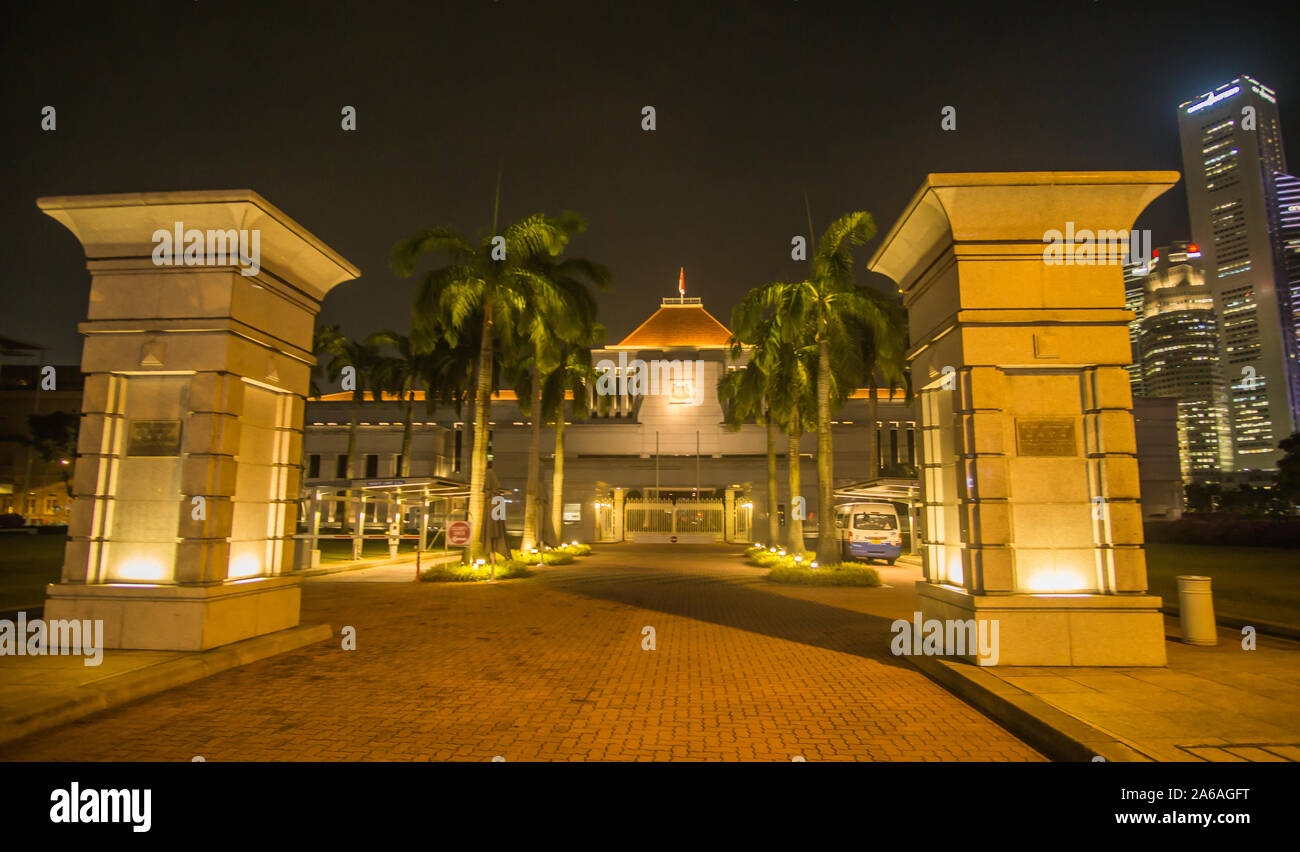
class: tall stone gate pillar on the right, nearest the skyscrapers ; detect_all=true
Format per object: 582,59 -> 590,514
870,172 -> 1178,666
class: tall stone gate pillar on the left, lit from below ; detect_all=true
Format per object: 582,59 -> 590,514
36,190 -> 360,650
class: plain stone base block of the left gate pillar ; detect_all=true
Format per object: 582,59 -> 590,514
44,576 -> 302,650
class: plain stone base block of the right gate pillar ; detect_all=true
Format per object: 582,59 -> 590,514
917,581 -> 1165,666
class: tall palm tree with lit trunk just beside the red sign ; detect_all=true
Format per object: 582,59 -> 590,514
390,212 -> 577,558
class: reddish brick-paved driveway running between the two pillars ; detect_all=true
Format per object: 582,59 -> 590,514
0,545 -> 1041,761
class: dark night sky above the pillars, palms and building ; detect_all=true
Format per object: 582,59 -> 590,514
0,0 -> 1300,363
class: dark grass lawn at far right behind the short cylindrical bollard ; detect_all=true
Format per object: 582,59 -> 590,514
1147,544 -> 1300,627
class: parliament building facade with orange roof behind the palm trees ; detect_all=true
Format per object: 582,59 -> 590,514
303,290 -> 918,541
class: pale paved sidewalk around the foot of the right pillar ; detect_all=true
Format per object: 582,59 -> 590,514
837,565 -> 1300,761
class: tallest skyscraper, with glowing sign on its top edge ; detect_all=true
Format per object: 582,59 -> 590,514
1178,75 -> 1300,476
